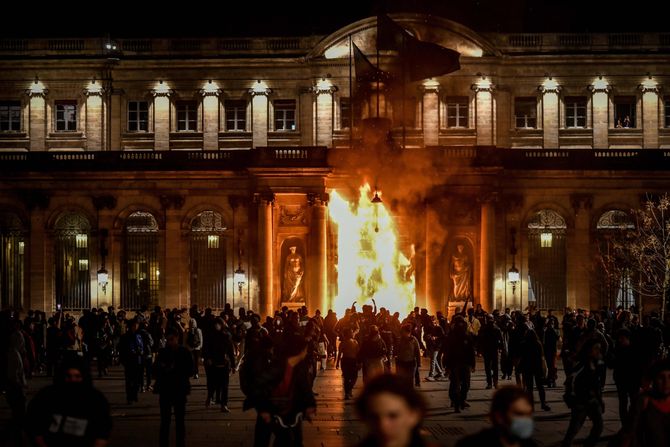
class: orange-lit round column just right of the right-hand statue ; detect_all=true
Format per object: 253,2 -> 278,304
479,194 -> 496,312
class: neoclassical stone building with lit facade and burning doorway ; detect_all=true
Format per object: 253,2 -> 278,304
0,14 -> 670,313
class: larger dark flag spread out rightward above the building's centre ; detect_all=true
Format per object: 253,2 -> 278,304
377,14 -> 461,82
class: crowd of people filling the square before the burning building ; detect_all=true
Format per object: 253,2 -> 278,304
0,304 -> 670,447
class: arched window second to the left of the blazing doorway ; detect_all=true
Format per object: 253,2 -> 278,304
121,211 -> 161,309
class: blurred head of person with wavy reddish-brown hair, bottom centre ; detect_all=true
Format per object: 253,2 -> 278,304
356,374 -> 438,447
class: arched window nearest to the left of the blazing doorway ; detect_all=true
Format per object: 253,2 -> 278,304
189,211 -> 226,309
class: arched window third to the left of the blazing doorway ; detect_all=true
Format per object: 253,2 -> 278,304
54,212 -> 92,309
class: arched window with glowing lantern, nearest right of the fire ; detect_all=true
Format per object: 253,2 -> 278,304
528,209 -> 567,309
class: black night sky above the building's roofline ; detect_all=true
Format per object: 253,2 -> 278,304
0,0 -> 670,37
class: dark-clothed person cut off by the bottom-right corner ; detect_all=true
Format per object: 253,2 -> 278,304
622,359 -> 670,447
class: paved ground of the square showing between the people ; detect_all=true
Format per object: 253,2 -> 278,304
0,359 -> 619,447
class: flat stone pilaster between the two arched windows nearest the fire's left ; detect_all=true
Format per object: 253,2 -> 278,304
159,195 -> 188,308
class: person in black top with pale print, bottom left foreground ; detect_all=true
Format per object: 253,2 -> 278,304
26,359 -> 112,447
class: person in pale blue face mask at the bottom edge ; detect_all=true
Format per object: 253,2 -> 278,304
456,386 -> 537,447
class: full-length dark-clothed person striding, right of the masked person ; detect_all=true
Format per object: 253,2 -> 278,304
562,339 -> 605,447
